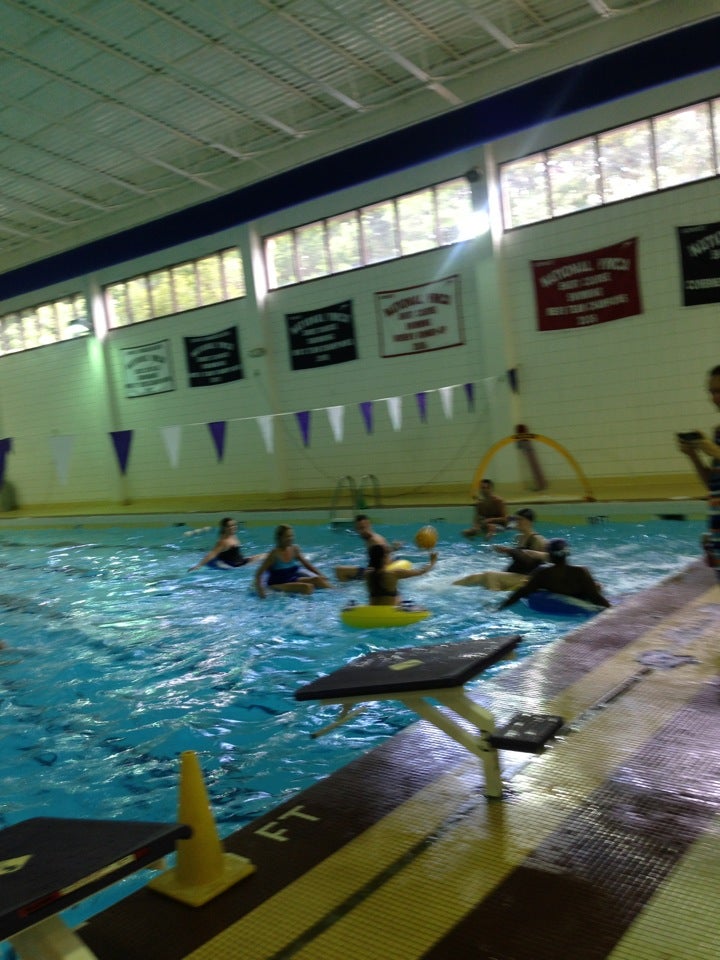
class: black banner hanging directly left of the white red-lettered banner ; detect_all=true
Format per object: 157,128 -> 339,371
285,300 -> 357,370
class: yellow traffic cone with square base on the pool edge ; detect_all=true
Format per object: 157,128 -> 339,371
149,750 -> 255,907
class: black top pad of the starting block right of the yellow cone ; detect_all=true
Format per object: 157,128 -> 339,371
295,635 -> 522,700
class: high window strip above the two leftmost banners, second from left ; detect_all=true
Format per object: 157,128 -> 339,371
105,249 -> 245,327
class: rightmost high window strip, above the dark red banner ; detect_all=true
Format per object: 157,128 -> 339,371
500,100 -> 720,230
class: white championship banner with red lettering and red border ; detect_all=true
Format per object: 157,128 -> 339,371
375,276 -> 465,357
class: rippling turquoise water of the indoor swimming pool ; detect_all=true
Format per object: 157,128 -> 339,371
0,519 -> 701,928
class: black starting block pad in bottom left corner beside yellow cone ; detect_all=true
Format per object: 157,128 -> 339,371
0,817 -> 192,941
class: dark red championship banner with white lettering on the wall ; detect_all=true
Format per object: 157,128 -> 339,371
532,237 -> 642,330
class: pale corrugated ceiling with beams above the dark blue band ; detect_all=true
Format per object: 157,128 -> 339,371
0,0 -> 718,271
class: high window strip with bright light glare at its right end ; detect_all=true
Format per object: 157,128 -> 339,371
265,177 -> 474,290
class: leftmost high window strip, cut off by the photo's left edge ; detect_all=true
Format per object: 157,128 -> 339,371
0,293 -> 92,355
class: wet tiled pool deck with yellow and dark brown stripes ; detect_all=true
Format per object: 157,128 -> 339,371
80,561 -> 720,960
